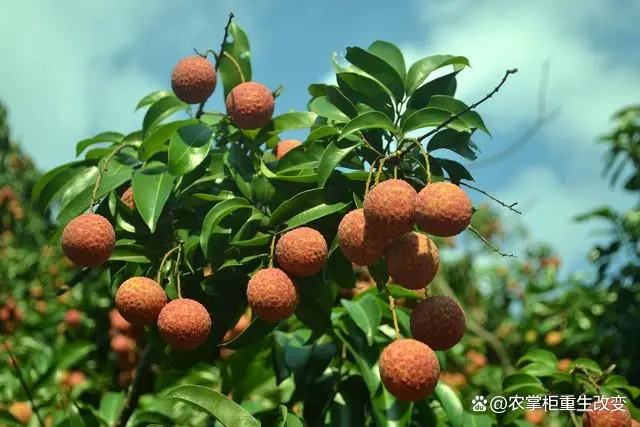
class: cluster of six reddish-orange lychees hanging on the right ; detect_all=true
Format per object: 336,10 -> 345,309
338,179 -> 473,401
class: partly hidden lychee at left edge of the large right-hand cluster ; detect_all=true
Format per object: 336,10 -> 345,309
338,209 -> 389,266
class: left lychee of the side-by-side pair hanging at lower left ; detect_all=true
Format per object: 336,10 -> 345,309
116,277 -> 167,326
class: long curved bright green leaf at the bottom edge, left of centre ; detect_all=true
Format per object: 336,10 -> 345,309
166,385 -> 260,427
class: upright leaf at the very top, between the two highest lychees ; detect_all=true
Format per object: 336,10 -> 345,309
218,22 -> 251,99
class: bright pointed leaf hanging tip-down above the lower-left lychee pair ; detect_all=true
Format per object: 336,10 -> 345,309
131,162 -> 176,233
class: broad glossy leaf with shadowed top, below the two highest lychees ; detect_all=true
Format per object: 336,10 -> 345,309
169,123 -> 213,175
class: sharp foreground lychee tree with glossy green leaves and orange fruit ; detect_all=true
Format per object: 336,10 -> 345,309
33,15 -> 640,426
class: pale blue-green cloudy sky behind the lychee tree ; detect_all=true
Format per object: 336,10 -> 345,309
0,0 -> 640,278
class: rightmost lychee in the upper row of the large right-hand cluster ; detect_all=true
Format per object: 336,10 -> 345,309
416,181 -> 473,237
